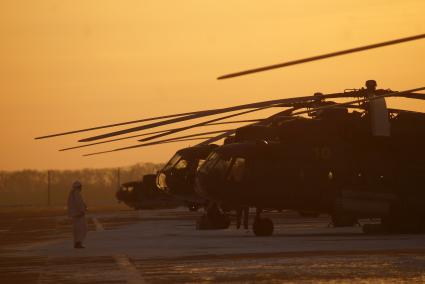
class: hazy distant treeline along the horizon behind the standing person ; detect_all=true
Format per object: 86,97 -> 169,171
0,163 -> 162,206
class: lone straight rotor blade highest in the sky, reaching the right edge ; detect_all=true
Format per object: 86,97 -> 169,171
217,34 -> 425,80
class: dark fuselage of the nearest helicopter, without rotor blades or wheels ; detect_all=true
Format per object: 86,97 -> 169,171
196,110 -> 425,220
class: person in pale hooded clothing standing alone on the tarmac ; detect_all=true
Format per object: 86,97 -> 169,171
68,181 -> 87,248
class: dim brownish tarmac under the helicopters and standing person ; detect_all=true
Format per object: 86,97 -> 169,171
0,209 -> 425,283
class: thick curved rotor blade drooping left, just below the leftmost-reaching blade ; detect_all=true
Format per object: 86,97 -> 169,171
79,93 -> 338,142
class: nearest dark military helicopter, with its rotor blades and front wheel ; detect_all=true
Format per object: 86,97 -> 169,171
36,34 -> 425,235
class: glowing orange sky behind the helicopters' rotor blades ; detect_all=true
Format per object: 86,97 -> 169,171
0,0 -> 425,170
